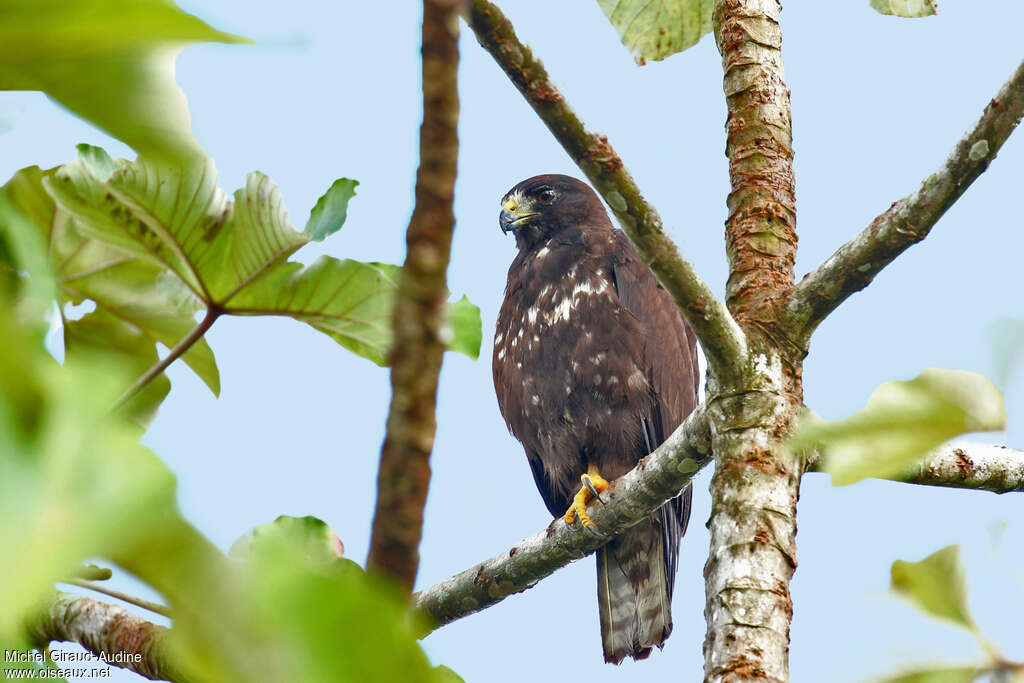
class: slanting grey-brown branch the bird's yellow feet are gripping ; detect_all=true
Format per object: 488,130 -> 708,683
414,405 -> 711,626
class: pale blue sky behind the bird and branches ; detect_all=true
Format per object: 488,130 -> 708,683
0,0 -> 1024,683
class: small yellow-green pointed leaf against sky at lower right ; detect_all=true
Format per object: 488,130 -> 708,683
892,546 -> 975,632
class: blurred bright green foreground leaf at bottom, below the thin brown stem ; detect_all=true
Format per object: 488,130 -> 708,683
171,528 -> 453,683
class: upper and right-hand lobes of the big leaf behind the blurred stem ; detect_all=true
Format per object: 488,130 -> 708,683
44,147 -> 480,365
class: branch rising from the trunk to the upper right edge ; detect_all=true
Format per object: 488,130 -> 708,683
784,54 -> 1024,348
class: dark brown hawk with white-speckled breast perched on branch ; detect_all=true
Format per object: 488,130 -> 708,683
493,175 -> 698,664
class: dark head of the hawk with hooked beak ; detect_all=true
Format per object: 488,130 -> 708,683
498,174 -> 610,249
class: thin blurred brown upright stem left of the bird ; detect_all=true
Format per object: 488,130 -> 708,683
367,0 -> 461,592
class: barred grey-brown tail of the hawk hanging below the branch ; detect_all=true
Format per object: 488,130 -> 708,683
597,515 -> 672,664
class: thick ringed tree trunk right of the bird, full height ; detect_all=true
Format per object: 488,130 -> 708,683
705,0 -> 803,682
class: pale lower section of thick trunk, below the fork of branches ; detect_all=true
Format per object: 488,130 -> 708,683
705,350 -> 802,682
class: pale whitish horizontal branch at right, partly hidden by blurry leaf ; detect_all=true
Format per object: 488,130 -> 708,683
808,443 -> 1024,494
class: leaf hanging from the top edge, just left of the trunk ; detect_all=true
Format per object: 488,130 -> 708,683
597,0 -> 715,65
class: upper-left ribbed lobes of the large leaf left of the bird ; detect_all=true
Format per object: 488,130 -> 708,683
46,159 -> 309,305
